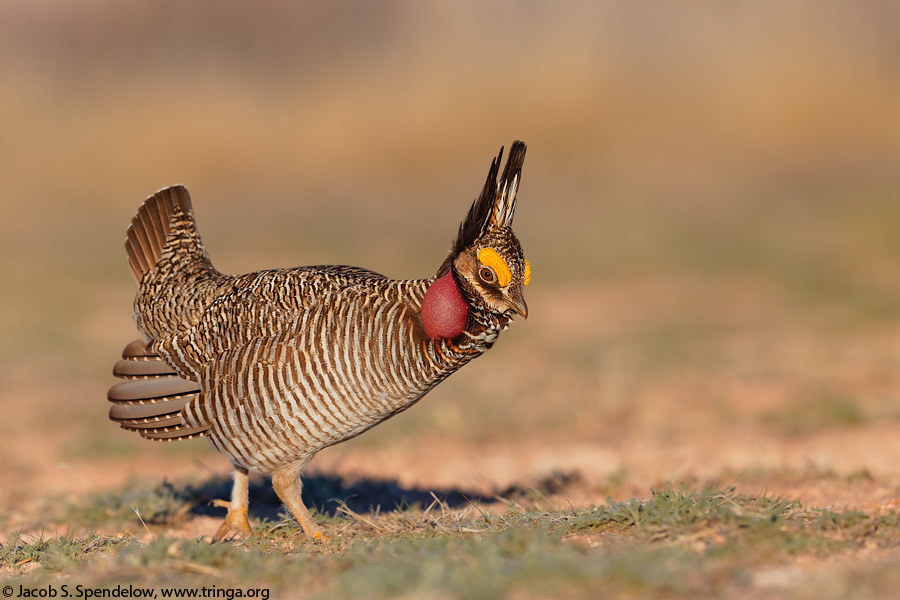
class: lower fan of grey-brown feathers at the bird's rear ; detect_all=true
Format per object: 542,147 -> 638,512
107,340 -> 209,442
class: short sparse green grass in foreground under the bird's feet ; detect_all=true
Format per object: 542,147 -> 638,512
7,483 -> 900,600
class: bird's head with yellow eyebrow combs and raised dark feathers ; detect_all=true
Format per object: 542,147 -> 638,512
423,141 -> 531,337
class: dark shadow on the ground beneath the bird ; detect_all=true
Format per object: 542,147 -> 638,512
166,473 -> 580,521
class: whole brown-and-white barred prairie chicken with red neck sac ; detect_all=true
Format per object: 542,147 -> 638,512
107,141 -> 531,541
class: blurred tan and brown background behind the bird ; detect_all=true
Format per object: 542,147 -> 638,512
0,0 -> 900,510
